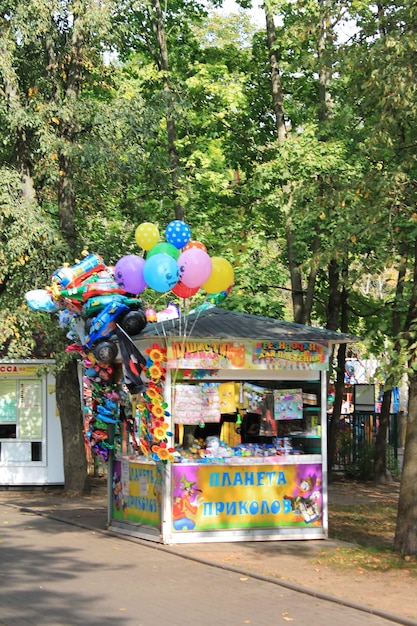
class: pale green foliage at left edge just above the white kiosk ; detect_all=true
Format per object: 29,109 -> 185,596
0,168 -> 68,358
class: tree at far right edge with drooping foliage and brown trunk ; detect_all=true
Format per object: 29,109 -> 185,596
338,0 -> 417,554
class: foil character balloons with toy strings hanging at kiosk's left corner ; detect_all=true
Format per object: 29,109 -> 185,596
25,254 -> 147,461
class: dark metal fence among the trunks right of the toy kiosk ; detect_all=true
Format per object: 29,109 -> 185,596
333,411 -> 398,478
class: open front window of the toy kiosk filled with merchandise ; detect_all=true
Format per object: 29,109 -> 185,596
173,380 -> 321,458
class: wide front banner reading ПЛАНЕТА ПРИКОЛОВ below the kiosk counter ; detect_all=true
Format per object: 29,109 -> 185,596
172,463 -> 323,533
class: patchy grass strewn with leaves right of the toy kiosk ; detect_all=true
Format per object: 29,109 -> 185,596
320,492 -> 417,578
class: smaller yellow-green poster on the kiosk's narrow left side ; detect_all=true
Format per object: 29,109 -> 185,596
111,460 -> 162,528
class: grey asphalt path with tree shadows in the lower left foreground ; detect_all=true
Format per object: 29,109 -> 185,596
0,505 -> 410,626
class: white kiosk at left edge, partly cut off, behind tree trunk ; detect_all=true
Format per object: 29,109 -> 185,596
0,360 -> 64,488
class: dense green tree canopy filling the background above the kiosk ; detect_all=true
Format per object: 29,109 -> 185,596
0,0 -> 417,380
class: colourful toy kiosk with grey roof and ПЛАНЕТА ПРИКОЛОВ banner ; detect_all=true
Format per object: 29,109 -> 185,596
109,308 -> 354,544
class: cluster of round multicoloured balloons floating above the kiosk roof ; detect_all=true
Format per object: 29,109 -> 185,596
114,220 -> 234,298
